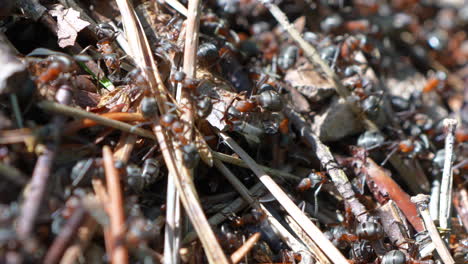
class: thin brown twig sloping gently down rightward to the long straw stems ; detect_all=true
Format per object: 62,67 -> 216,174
38,101 -> 156,140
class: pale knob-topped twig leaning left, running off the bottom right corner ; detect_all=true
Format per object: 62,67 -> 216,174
411,194 -> 455,264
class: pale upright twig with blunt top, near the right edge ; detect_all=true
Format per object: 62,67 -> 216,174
439,119 -> 457,234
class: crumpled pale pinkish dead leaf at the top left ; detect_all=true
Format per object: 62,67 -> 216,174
49,5 -> 89,48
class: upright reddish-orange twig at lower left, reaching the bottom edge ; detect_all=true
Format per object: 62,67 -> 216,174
102,146 -> 128,264
